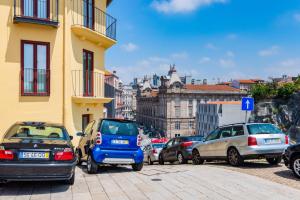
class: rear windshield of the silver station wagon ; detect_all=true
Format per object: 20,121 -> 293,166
247,124 -> 282,135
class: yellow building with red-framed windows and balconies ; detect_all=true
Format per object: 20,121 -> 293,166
0,0 -> 116,143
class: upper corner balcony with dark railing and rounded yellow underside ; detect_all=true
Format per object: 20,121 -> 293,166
72,0 -> 117,48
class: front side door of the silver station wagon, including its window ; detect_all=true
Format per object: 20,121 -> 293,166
199,129 -> 220,157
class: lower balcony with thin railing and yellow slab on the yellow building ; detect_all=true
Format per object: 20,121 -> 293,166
72,70 -> 112,105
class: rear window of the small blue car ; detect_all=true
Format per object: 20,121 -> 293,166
100,120 -> 139,136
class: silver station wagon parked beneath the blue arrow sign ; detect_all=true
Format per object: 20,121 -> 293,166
192,123 -> 289,166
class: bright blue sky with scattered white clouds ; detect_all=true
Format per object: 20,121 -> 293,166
105,0 -> 300,83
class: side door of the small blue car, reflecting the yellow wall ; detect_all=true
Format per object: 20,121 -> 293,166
79,121 -> 95,158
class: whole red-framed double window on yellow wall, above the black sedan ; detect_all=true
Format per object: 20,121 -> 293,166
21,41 -> 50,96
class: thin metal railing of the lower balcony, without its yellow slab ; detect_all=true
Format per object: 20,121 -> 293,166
72,70 -> 104,98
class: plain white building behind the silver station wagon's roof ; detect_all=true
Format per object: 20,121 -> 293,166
196,101 -> 250,136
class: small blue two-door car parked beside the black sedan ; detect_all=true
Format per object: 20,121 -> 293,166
75,119 -> 144,174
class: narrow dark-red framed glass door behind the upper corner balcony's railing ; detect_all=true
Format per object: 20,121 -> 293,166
82,0 -> 95,29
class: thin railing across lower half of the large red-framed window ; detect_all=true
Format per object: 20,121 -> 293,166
21,68 -> 50,96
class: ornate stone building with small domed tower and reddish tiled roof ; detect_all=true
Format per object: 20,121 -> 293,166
136,66 -> 246,137
